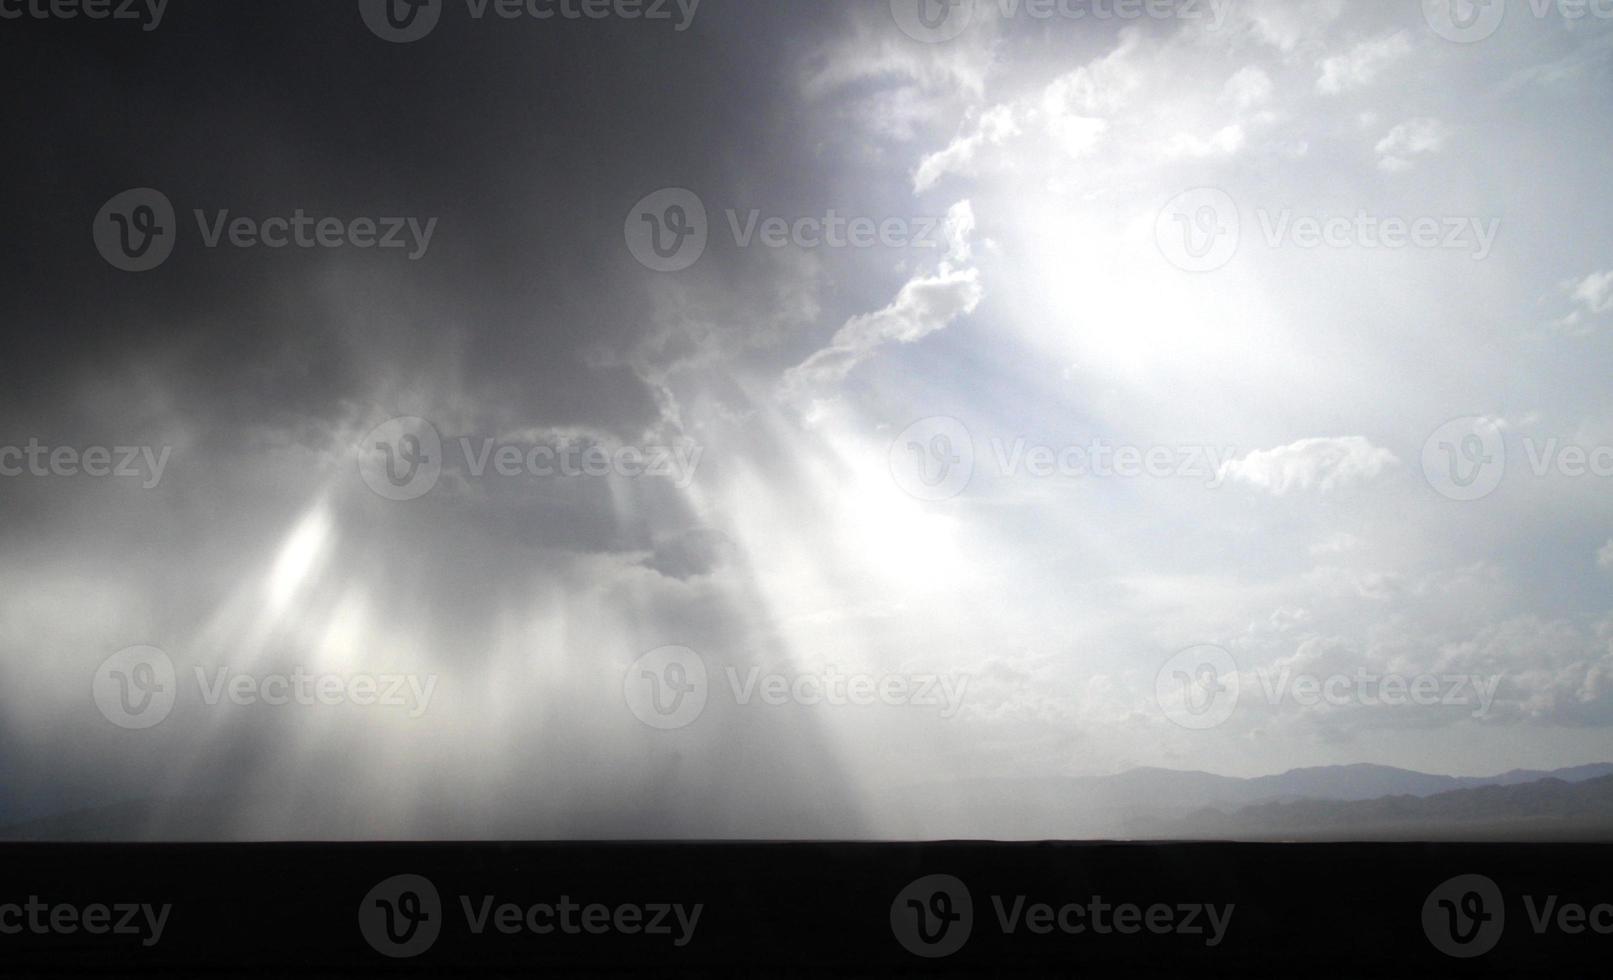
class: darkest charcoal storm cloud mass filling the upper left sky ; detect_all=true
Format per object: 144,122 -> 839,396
0,0 -> 845,445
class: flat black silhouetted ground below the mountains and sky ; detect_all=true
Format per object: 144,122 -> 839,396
0,843 -> 1613,977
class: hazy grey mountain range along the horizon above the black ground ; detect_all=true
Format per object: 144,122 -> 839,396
9,764 -> 1613,841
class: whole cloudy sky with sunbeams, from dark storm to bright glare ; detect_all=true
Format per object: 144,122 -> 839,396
0,0 -> 1613,838
